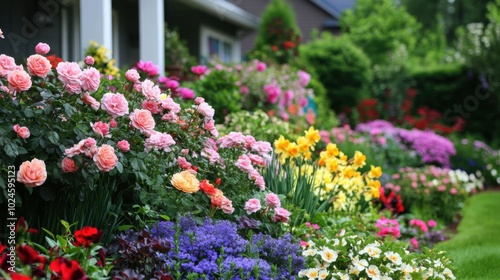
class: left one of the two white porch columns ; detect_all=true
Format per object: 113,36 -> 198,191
80,0 -> 114,59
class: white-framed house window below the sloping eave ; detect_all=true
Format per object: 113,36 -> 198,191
200,26 -> 241,63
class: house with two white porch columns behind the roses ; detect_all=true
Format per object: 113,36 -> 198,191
0,0 -> 259,72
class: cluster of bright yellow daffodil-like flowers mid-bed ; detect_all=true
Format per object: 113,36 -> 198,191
274,127 -> 382,212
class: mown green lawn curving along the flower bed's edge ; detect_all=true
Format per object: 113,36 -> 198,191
436,192 -> 500,280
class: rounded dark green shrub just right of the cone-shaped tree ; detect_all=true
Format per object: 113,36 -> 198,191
300,33 -> 372,112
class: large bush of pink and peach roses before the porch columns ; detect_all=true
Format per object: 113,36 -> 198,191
0,43 -> 278,236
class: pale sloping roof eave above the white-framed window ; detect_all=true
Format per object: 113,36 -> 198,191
182,0 -> 260,29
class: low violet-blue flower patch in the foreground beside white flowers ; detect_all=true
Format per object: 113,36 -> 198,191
150,216 -> 304,279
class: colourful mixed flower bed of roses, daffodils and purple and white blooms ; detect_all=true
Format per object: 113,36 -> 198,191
0,42 -> 494,279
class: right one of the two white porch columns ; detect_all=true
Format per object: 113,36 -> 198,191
139,0 -> 165,75
